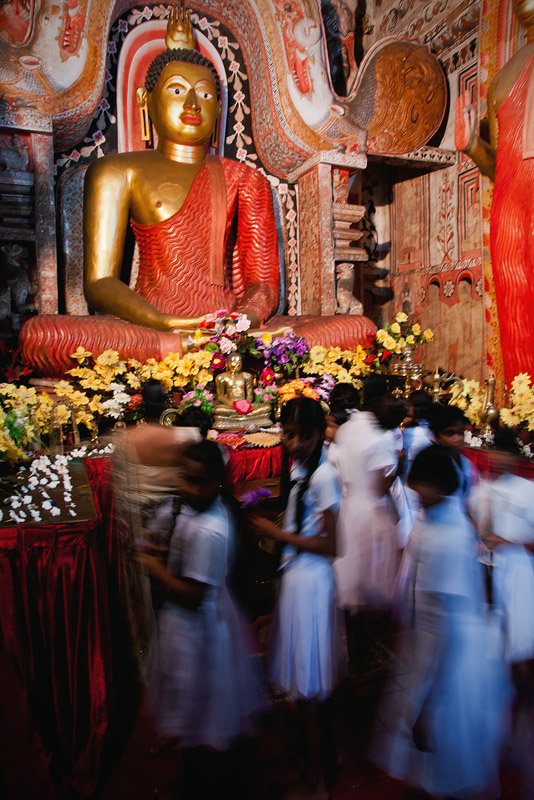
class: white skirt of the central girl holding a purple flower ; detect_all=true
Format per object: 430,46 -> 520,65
270,553 -> 344,701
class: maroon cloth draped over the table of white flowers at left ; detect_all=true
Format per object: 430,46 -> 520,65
0,458 -> 138,800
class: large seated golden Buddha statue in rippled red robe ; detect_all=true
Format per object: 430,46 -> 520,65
20,0 -> 374,377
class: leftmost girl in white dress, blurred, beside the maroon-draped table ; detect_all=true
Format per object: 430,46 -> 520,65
138,441 -> 265,791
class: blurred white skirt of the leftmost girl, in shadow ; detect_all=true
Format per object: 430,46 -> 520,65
153,588 -> 267,750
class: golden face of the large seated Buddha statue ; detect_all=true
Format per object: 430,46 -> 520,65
147,61 -> 220,145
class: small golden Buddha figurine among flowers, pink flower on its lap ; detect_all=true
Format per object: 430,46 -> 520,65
213,353 -> 273,431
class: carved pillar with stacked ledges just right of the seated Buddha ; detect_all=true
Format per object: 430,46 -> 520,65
287,151 -> 367,316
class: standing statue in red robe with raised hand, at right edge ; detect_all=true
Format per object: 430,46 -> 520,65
456,0 -> 534,381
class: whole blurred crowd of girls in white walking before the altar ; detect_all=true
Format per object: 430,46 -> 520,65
115,375 -> 534,800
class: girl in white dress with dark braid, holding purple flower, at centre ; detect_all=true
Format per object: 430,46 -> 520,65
253,396 -> 341,798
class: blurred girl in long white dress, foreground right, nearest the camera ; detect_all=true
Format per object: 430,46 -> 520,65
374,445 -> 508,799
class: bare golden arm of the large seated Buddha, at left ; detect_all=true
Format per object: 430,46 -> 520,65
83,156 -> 204,332
